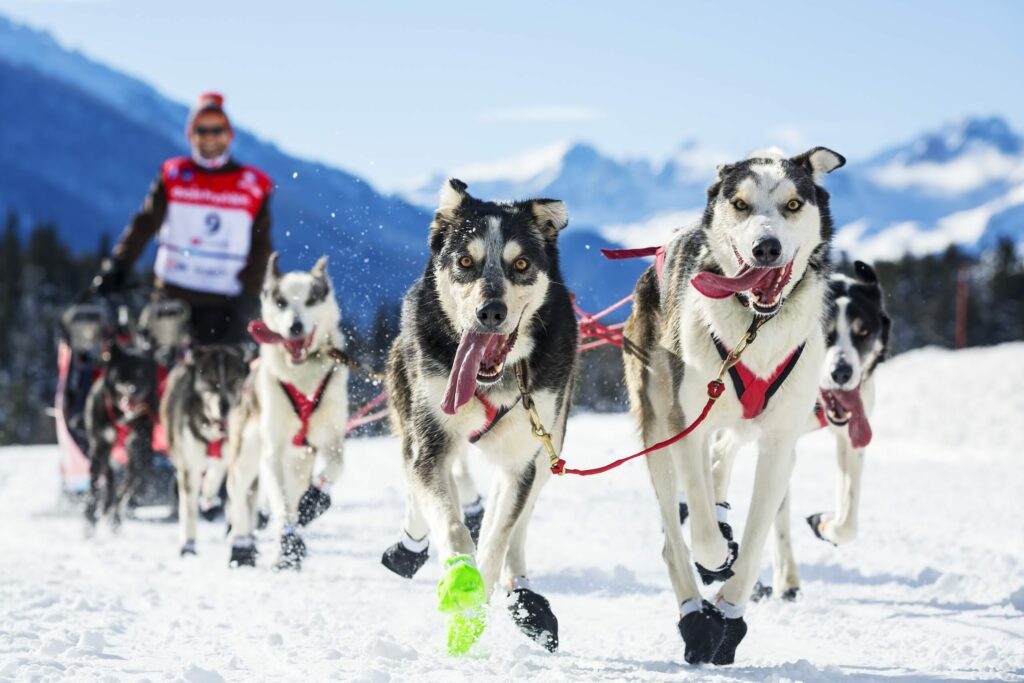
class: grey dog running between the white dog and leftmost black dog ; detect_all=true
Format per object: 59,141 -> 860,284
160,344 -> 249,555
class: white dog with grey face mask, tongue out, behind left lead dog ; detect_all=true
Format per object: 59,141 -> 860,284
227,253 -> 348,569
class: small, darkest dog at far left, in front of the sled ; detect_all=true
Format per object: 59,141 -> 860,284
85,343 -> 157,532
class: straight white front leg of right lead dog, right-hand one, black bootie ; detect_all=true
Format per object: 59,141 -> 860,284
712,433 -> 797,665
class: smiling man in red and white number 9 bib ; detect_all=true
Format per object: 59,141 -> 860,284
92,92 -> 273,344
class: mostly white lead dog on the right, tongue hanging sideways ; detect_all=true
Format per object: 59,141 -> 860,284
624,147 -> 845,665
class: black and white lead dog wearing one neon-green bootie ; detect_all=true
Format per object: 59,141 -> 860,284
385,179 -> 577,653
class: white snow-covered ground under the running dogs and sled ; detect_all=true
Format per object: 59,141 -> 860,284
0,343 -> 1024,682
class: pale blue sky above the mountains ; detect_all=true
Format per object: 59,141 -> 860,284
0,0 -> 1024,188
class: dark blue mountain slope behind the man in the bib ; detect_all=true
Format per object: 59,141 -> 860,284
0,16 -> 641,326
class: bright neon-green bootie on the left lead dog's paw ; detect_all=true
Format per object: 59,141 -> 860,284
437,555 -> 487,654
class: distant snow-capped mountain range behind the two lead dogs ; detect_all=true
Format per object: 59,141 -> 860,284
403,117 -> 1024,258
